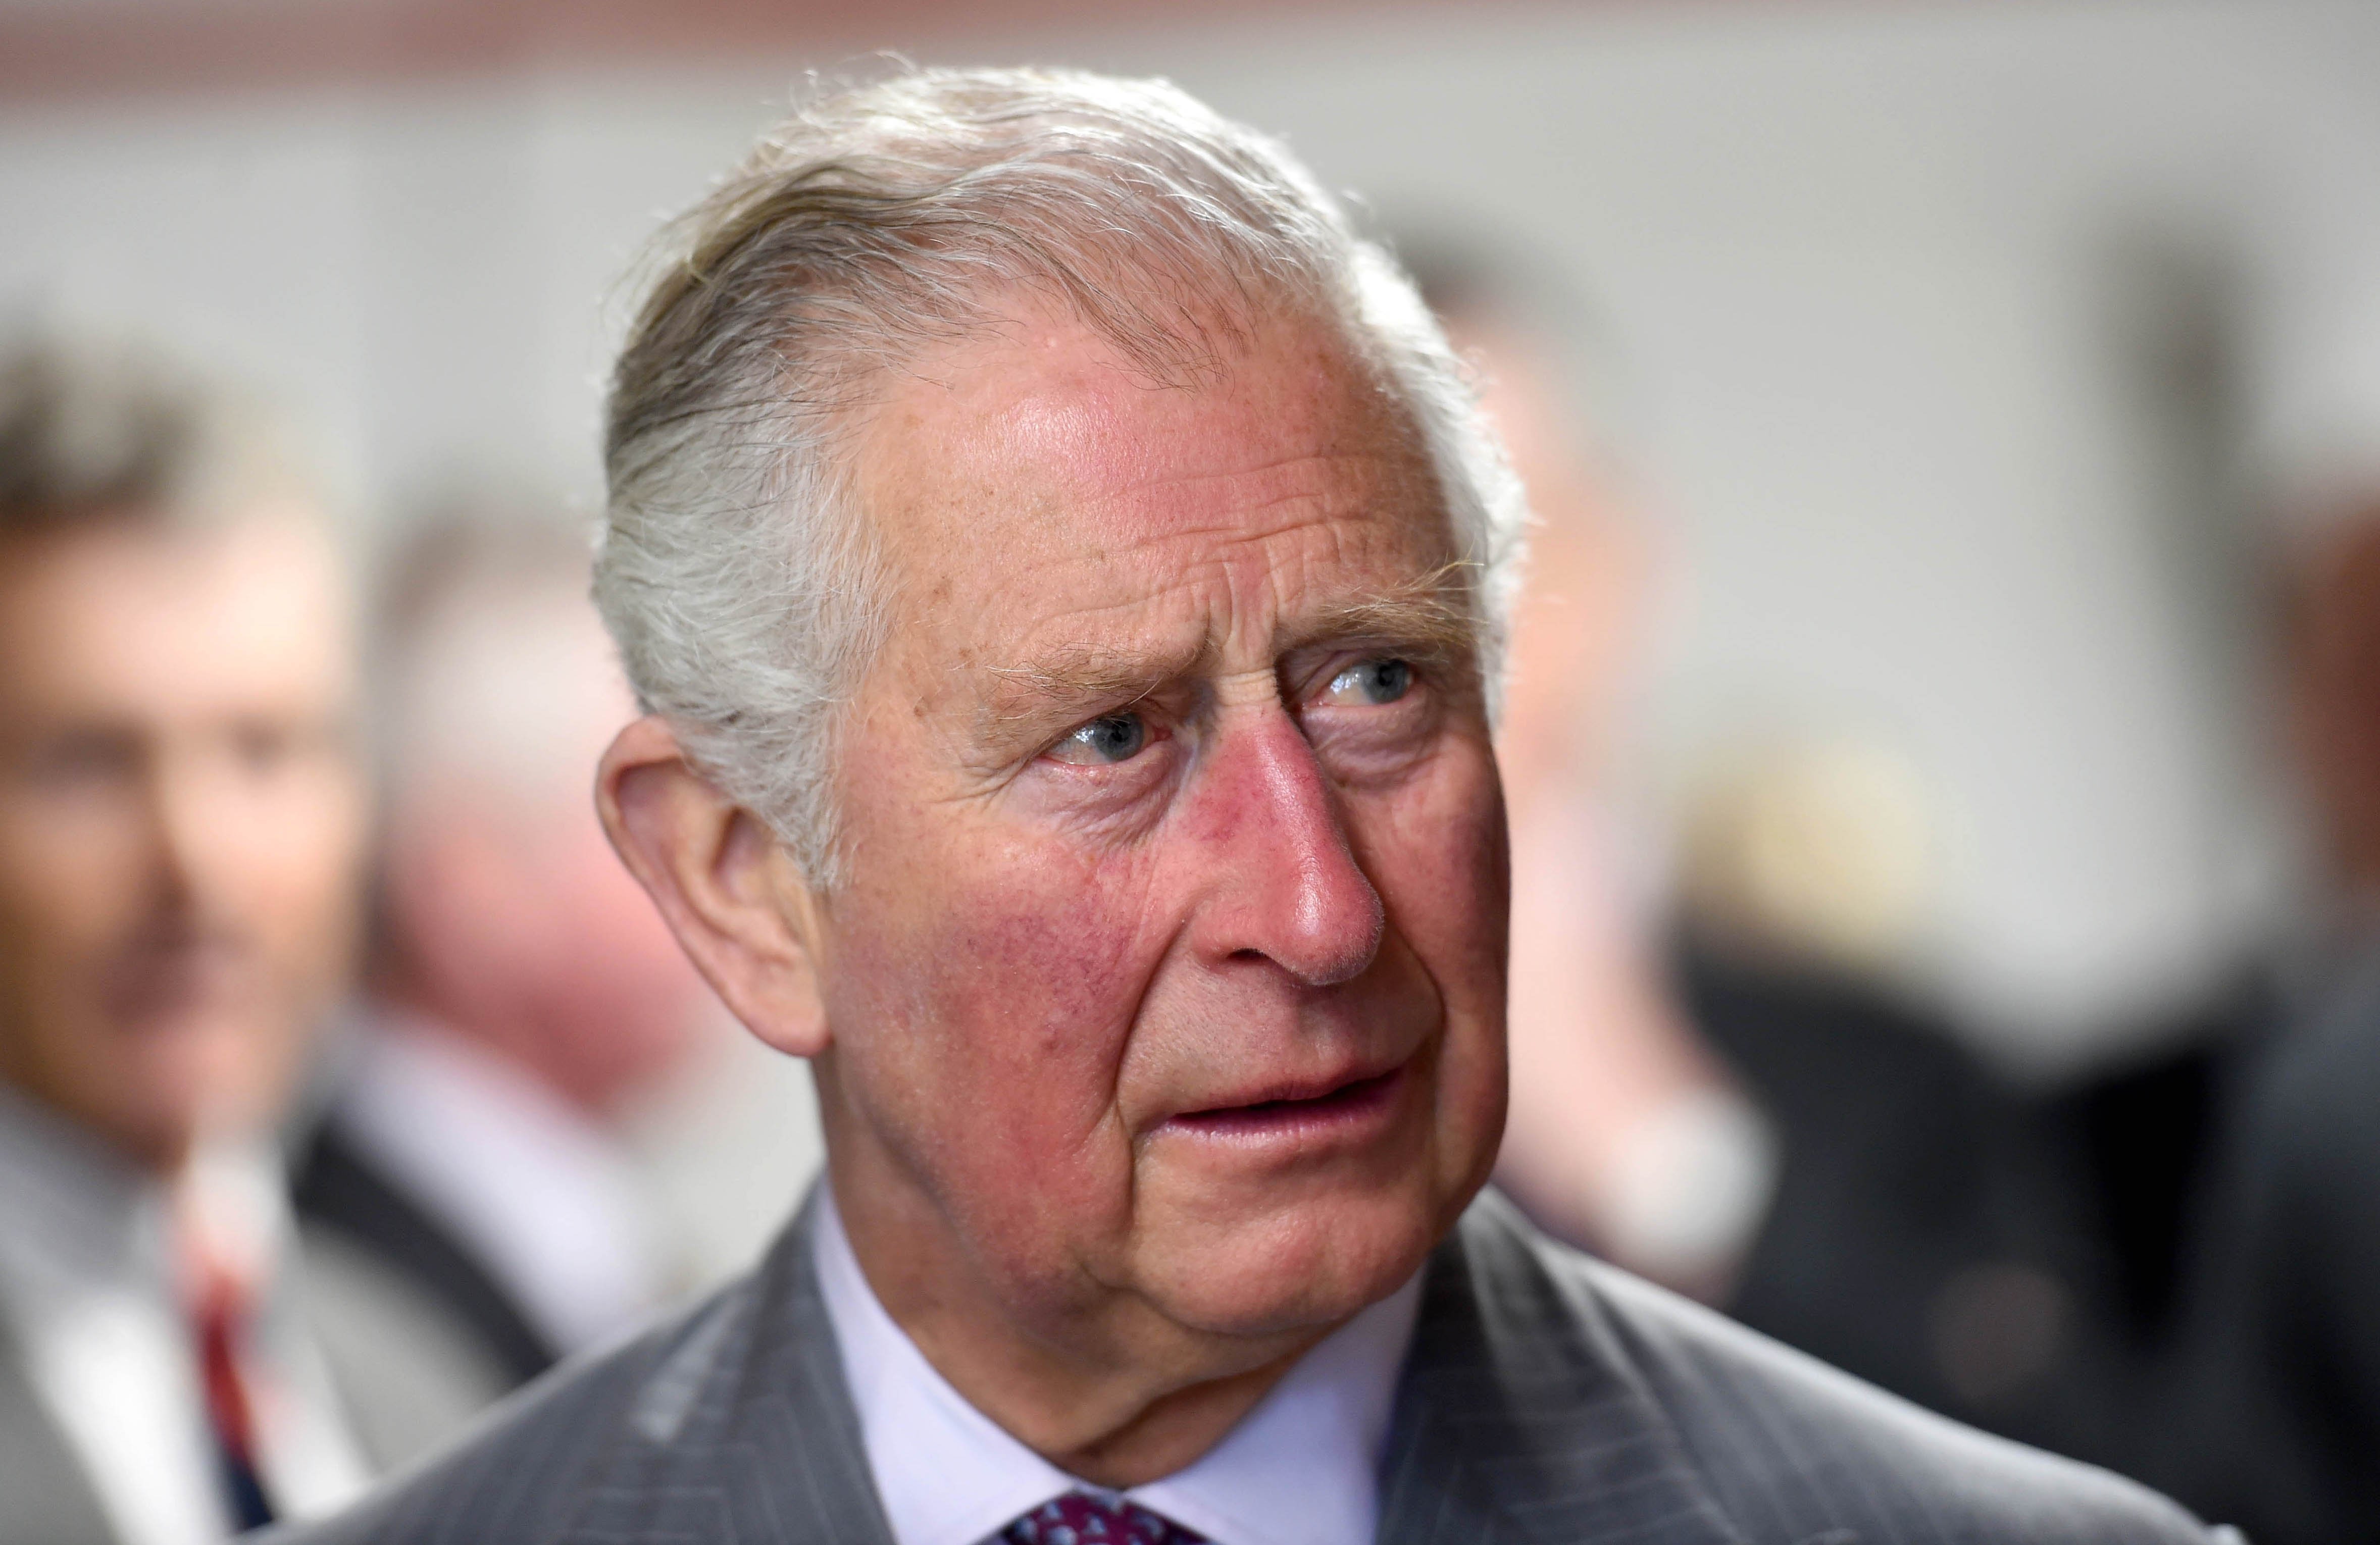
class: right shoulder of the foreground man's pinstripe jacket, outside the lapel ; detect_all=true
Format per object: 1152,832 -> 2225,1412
1442,1193 -> 2223,1545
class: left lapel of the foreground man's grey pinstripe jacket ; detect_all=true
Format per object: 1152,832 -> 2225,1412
557,1202 -> 892,1545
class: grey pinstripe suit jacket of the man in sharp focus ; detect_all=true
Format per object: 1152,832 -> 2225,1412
281,1193 -> 2227,1545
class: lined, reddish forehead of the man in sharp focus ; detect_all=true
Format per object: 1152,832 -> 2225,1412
857,304 -> 1452,652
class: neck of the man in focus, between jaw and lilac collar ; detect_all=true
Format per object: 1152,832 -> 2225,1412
819,1086 -> 1335,1490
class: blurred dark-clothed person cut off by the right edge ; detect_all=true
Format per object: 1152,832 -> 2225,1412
2142,495 -> 2380,1545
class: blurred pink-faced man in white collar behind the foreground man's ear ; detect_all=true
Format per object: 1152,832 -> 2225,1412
297,500 -> 707,1381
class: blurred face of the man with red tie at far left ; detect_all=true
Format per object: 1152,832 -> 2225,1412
0,514 -> 364,1169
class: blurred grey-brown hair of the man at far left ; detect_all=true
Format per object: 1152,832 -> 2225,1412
0,333 -> 317,531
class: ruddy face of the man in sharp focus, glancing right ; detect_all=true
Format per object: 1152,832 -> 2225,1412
819,307 -> 1504,1335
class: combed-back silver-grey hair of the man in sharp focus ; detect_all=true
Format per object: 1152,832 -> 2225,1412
595,69 -> 1526,886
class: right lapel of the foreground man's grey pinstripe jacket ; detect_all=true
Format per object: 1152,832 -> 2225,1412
1381,1193 -> 1745,1545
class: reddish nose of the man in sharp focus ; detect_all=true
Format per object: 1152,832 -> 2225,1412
1188,709 -> 1383,988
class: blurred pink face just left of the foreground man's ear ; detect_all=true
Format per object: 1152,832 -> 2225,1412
378,597 -> 717,1114
